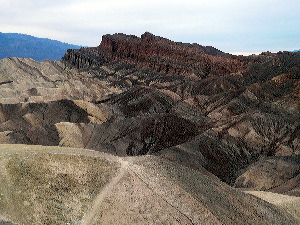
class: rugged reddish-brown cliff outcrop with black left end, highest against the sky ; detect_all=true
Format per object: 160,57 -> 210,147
62,32 -> 243,78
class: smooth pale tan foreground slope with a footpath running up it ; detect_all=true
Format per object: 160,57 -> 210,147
0,145 -> 300,224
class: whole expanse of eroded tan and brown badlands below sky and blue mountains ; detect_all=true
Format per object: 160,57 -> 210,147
0,32 -> 300,224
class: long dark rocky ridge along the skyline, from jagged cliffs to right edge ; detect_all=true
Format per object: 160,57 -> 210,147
62,32 -> 300,84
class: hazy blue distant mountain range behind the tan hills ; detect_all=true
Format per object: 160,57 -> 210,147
0,32 -> 82,61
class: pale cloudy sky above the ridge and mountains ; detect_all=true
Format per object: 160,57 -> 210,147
0,0 -> 300,54
